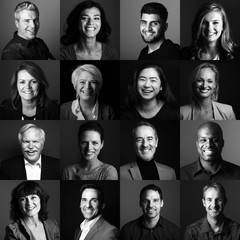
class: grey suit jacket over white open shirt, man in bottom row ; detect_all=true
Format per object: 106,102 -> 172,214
74,217 -> 119,240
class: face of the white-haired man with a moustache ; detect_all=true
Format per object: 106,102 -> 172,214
21,128 -> 44,164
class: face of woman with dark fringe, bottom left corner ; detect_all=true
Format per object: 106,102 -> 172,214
19,194 -> 41,218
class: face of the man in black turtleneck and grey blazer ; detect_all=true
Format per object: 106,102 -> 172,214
134,126 -> 158,162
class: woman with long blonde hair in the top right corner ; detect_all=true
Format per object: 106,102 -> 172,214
181,2 -> 240,60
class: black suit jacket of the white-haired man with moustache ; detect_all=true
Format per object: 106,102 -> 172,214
0,154 -> 60,180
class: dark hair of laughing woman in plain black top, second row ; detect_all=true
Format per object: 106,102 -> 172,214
126,62 -> 175,107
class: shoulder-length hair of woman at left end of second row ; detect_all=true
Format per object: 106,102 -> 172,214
11,61 -> 49,109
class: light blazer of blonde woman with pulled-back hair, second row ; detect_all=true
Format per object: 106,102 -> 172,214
180,101 -> 236,120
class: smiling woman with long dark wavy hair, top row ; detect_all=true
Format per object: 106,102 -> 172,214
60,0 -> 119,60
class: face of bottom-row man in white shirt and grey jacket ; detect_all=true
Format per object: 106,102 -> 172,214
80,188 -> 103,221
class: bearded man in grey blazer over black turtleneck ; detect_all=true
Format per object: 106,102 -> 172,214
120,121 -> 176,180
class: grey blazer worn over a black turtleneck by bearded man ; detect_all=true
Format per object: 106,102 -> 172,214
120,161 -> 176,180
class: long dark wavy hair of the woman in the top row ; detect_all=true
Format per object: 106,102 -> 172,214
61,0 -> 111,45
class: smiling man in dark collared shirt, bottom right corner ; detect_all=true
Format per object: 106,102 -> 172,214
183,183 -> 240,240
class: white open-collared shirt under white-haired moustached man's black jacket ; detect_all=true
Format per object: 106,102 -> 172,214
24,155 -> 42,180
